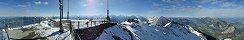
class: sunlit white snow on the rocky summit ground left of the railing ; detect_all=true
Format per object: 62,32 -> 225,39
1,21 -> 72,40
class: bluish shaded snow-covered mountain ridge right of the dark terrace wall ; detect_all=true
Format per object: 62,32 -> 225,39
96,22 -> 204,40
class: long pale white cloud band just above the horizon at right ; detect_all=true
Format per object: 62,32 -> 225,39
148,8 -> 244,17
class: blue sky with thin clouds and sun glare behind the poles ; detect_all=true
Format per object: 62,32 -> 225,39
0,0 -> 244,17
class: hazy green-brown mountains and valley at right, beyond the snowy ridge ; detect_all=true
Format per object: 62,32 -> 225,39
169,17 -> 244,40
